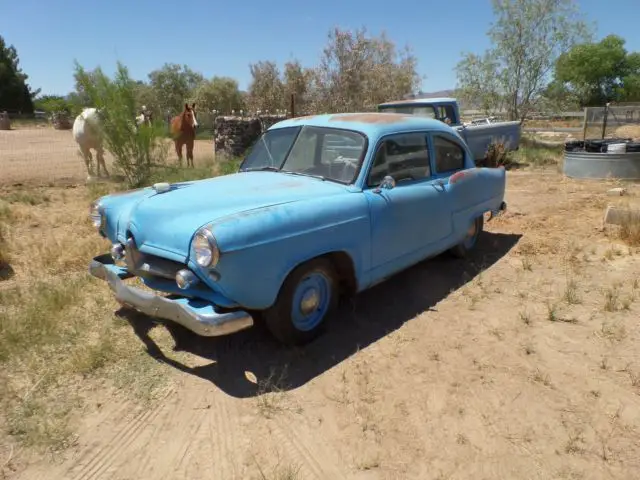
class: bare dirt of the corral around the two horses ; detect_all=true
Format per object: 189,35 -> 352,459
0,126 -> 214,185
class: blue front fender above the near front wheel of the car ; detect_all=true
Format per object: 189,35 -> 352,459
200,192 -> 371,310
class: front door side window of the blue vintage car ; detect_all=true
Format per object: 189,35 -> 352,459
367,133 -> 431,187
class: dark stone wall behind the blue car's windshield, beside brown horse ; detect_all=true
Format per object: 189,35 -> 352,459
213,115 -> 286,157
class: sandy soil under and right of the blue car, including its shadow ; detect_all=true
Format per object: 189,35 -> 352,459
6,169 -> 640,480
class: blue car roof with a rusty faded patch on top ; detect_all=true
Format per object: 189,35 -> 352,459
269,112 -> 457,138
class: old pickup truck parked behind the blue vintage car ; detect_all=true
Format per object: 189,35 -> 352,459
378,98 -> 521,163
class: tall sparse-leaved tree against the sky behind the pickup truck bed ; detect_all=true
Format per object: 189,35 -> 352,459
456,0 -> 591,122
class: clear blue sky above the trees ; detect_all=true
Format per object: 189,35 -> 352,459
0,0 -> 640,94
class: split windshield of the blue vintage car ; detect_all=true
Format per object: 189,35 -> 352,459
240,125 -> 367,184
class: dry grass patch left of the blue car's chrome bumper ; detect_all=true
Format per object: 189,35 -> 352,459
0,187 -> 175,450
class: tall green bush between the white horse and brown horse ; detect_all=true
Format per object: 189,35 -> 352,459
75,62 -> 169,188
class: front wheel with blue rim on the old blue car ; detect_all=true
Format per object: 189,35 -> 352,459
263,258 -> 338,345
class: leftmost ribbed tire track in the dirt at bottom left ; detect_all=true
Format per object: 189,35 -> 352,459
63,390 -> 173,480
